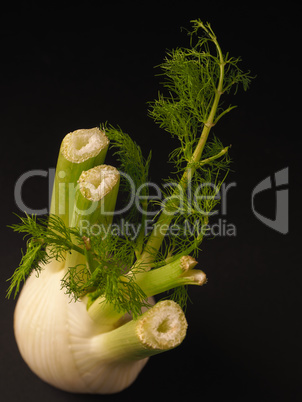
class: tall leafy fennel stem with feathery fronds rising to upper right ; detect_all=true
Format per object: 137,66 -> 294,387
143,20 -> 251,261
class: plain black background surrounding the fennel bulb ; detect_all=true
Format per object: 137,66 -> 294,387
0,1 -> 302,402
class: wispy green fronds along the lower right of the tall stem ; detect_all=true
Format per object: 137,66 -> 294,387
146,162 -> 224,265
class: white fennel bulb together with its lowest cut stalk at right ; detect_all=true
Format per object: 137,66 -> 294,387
14,261 -> 186,394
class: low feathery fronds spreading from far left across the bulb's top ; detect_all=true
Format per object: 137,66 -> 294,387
7,215 -> 148,317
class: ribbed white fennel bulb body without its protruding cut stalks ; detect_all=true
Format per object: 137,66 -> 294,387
14,262 -> 147,394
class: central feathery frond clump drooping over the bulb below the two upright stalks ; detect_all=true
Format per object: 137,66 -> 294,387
62,233 -> 147,317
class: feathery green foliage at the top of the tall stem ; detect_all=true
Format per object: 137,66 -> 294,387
149,20 -> 251,168
